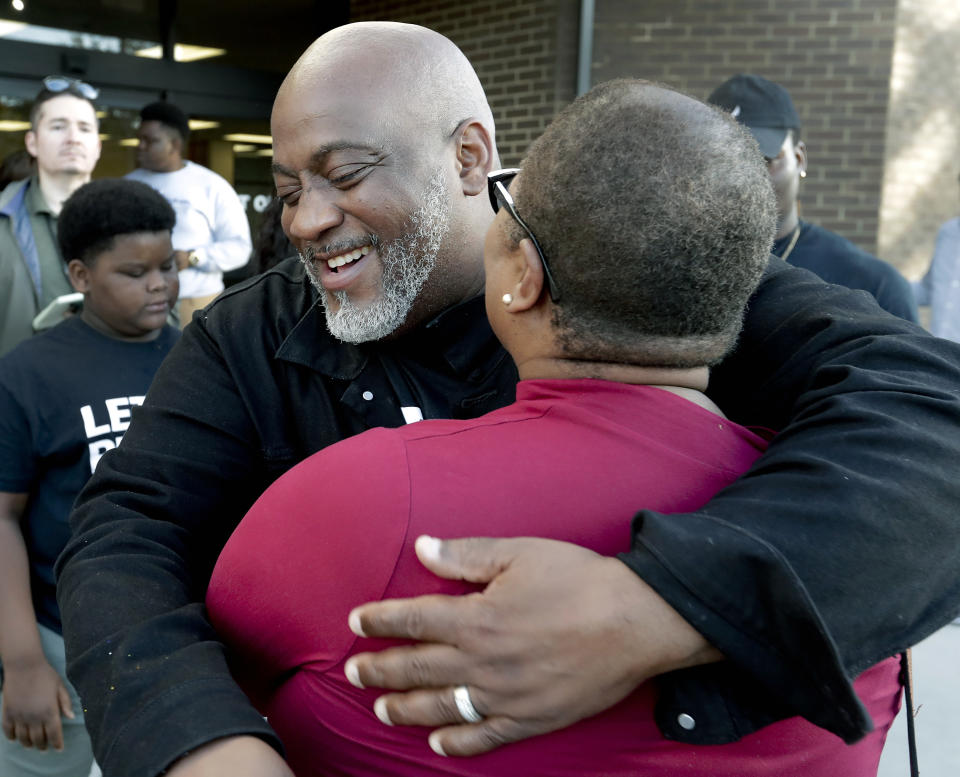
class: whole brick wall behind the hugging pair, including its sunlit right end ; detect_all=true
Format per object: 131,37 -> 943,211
351,0 -> 960,277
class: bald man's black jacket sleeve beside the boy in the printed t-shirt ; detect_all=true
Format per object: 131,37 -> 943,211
57,322 -> 280,777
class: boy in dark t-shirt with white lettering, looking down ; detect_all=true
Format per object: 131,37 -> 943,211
0,179 -> 179,777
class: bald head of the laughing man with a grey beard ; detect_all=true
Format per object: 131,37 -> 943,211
271,22 -> 497,342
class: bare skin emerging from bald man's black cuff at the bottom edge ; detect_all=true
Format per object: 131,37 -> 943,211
165,736 -> 294,777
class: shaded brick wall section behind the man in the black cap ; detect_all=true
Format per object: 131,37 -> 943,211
592,0 -> 900,258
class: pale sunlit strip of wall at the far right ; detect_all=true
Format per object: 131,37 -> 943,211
879,0 -> 960,277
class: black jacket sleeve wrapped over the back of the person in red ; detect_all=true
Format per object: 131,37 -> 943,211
621,260 -> 960,741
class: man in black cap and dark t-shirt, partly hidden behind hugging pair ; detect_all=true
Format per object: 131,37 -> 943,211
707,73 -> 917,321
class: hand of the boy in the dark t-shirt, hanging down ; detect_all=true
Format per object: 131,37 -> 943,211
3,656 -> 75,750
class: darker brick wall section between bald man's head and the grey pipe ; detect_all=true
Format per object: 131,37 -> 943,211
350,0 -> 579,166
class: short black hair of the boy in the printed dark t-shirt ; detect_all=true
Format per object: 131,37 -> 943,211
57,178 -> 177,265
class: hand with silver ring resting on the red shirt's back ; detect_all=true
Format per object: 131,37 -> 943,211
345,537 -> 721,755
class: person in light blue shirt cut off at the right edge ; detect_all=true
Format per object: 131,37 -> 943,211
912,179 -> 960,342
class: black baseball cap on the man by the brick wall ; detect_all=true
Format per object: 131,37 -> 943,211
707,73 -> 800,159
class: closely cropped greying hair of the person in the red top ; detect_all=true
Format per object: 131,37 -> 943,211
508,79 -> 776,367
